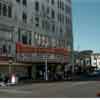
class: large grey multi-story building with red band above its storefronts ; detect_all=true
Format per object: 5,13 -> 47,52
0,0 -> 73,78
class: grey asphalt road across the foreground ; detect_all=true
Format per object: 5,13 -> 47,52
0,81 -> 100,98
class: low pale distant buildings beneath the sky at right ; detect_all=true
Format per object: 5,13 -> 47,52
74,50 -> 100,71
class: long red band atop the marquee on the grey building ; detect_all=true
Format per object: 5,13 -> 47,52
16,43 -> 68,56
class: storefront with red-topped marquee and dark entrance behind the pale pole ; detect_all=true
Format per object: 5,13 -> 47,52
16,43 -> 68,80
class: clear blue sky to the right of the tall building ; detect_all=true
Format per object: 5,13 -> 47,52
72,0 -> 100,52
